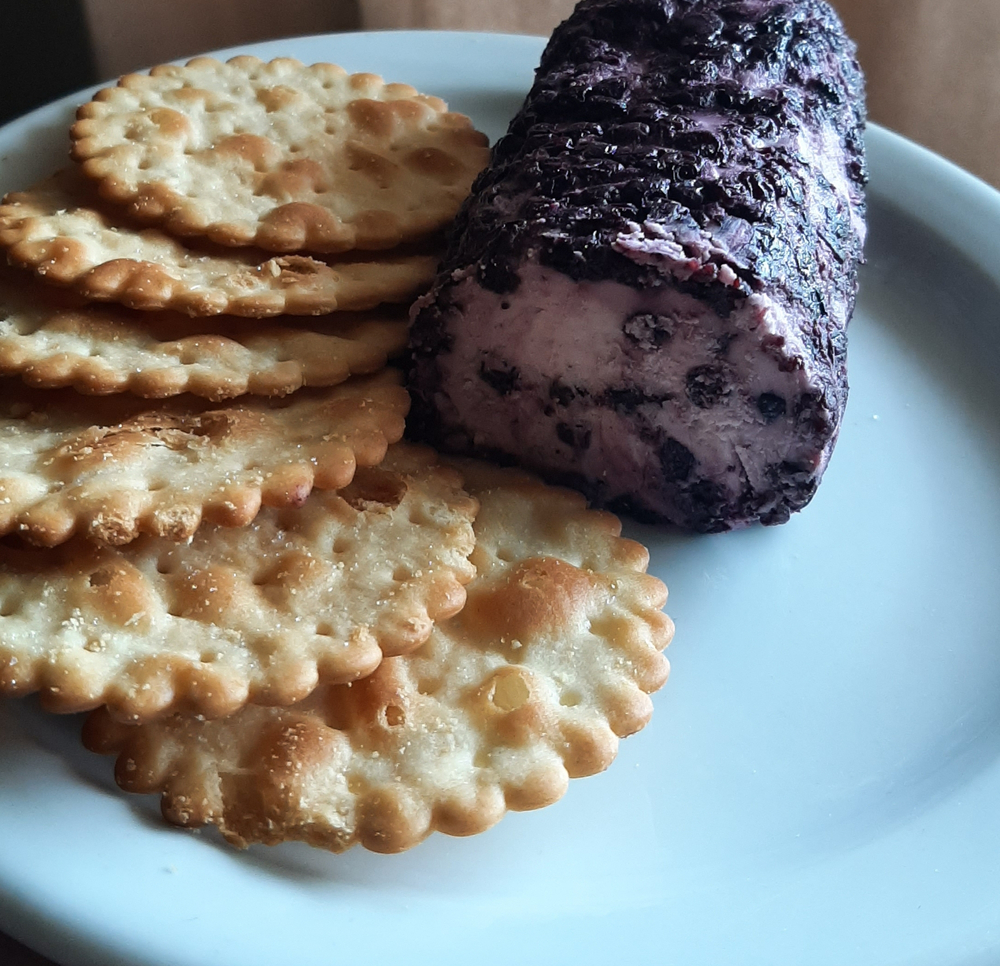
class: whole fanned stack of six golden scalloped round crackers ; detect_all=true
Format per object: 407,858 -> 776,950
0,57 -> 672,852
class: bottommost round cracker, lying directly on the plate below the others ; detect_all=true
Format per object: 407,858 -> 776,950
85,462 -> 673,852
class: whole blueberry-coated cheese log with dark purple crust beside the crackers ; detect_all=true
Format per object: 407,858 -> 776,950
410,0 -> 866,532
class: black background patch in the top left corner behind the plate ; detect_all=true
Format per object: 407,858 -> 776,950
0,0 -> 97,123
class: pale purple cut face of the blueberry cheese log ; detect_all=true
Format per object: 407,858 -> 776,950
433,262 -> 832,519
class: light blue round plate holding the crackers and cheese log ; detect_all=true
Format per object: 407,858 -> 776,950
0,33 -> 1000,966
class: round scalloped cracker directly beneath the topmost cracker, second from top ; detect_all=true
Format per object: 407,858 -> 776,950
0,168 -> 437,318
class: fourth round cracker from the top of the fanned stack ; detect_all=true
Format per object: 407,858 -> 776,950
0,370 -> 409,547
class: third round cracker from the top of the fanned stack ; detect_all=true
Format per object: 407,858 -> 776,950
0,267 -> 407,401
